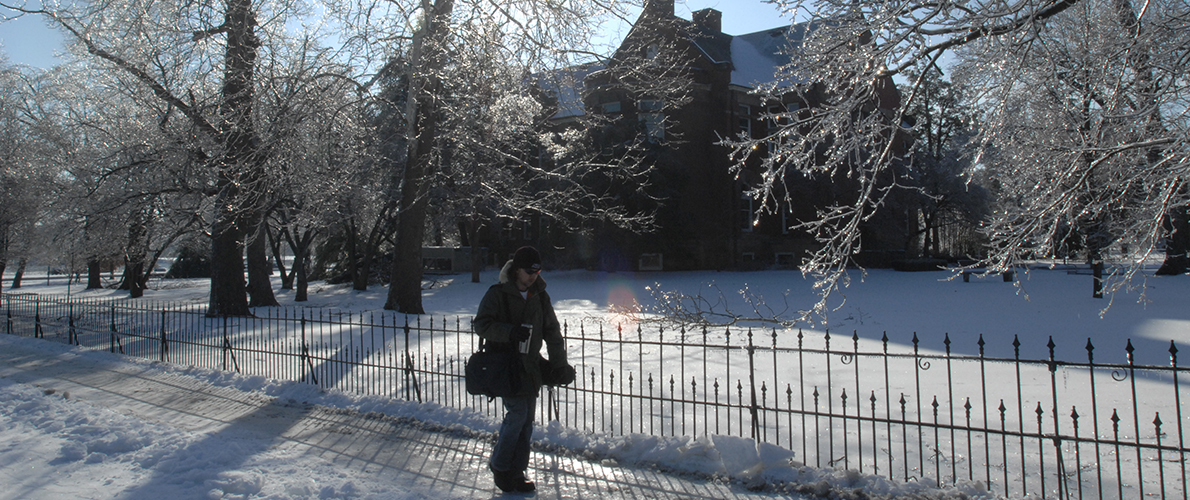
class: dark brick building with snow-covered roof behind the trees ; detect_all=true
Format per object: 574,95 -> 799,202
487,0 -> 904,270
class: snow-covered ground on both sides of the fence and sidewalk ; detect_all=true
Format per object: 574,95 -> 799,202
0,263 -> 1190,499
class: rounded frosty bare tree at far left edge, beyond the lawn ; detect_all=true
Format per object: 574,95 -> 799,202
4,59 -> 207,298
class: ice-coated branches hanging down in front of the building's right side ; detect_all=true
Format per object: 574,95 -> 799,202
718,0 -> 1190,321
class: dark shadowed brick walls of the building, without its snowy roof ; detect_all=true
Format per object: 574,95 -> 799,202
540,0 -> 900,270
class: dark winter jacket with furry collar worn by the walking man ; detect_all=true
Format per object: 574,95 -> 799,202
472,261 -> 566,395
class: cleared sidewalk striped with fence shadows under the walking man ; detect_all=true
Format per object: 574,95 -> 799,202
0,335 -> 804,499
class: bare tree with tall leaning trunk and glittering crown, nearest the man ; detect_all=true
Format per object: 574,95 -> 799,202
323,0 -> 642,313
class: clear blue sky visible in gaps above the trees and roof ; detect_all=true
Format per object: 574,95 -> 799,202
0,0 -> 790,68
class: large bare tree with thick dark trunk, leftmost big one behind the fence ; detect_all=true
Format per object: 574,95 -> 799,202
6,0 -> 371,315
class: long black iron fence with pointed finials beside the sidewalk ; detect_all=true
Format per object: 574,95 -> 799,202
2,294 -> 1190,499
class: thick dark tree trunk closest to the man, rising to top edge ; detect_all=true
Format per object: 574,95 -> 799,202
384,0 -> 455,314
